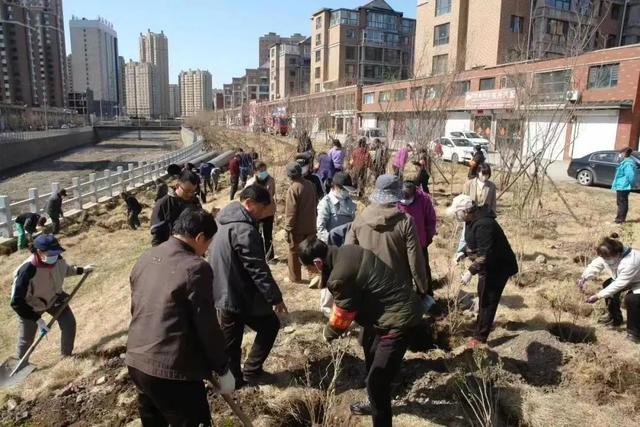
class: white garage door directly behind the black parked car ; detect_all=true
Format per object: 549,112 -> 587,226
571,111 -> 618,159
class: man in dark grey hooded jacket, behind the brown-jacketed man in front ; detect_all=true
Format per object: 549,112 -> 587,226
209,185 -> 287,388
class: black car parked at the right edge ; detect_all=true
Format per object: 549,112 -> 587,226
567,151 -> 640,189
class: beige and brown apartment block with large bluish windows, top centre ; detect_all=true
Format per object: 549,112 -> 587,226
311,0 -> 416,93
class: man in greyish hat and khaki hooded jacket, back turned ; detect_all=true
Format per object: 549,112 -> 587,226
345,175 -> 431,296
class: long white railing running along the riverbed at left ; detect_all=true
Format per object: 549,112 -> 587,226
0,138 -> 203,238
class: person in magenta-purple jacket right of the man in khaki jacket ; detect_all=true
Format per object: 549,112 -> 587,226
398,179 -> 436,296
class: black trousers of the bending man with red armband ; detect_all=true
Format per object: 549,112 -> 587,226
360,328 -> 408,427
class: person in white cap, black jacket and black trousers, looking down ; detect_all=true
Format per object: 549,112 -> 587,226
447,194 -> 518,348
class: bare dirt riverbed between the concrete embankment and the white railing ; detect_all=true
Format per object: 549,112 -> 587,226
0,131 -> 182,200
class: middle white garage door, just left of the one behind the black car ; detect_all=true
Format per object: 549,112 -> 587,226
523,113 -> 567,161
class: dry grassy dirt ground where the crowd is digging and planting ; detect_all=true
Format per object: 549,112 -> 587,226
0,131 -> 640,427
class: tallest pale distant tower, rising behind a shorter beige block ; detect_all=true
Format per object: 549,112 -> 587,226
140,30 -> 169,117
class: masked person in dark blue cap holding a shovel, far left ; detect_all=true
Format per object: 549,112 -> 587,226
11,234 -> 94,359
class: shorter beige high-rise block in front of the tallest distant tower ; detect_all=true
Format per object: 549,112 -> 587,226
125,60 -> 159,118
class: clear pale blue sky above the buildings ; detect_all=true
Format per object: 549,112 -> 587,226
63,0 -> 417,88
